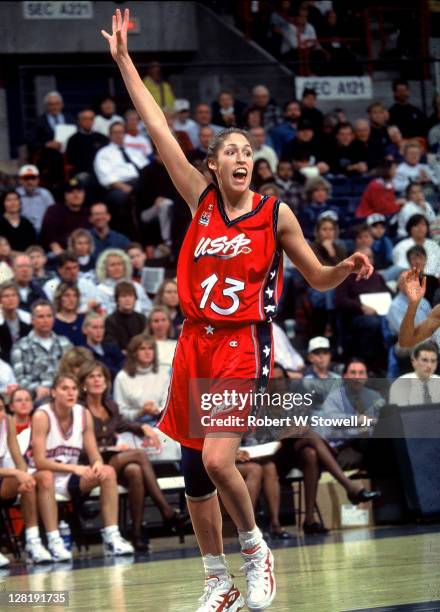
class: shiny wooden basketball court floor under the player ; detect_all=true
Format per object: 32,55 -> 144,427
0,525 -> 440,612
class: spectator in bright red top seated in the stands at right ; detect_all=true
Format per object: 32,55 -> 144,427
356,160 -> 404,217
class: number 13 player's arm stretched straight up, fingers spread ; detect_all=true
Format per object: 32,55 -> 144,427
101,9 -> 208,214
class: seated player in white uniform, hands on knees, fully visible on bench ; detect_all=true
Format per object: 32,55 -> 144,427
32,374 -> 133,561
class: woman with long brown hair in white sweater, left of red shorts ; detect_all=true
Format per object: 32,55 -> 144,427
113,334 -> 170,425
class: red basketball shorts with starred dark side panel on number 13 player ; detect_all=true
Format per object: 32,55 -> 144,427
158,321 -> 273,450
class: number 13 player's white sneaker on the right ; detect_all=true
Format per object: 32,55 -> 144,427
241,542 -> 276,610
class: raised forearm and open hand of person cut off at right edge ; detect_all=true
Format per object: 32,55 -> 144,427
399,268 -> 440,348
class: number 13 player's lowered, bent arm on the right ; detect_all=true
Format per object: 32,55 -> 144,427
277,204 -> 373,291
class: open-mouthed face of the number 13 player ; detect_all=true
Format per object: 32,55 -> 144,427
209,133 -> 254,192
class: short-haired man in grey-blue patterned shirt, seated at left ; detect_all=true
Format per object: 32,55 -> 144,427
11,300 -> 71,400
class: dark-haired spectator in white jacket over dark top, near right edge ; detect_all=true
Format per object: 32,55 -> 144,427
393,214 -> 440,278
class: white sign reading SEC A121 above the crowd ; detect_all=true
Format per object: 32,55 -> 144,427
295,76 -> 373,100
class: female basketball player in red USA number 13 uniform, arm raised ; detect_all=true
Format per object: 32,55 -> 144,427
102,9 -> 372,612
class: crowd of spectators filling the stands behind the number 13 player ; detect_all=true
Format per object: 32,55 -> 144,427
0,65 -> 440,560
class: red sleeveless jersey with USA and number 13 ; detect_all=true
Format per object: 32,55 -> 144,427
177,185 -> 283,327
